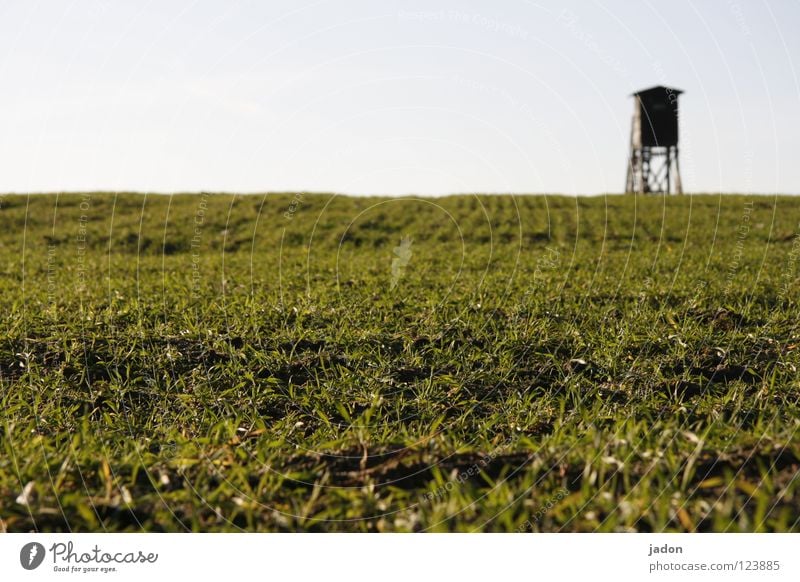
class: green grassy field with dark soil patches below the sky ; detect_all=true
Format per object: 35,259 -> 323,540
0,193 -> 800,532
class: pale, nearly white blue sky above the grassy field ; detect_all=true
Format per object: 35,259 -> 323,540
0,0 -> 800,194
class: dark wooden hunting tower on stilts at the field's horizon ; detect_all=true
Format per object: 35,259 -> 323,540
625,85 -> 683,194
